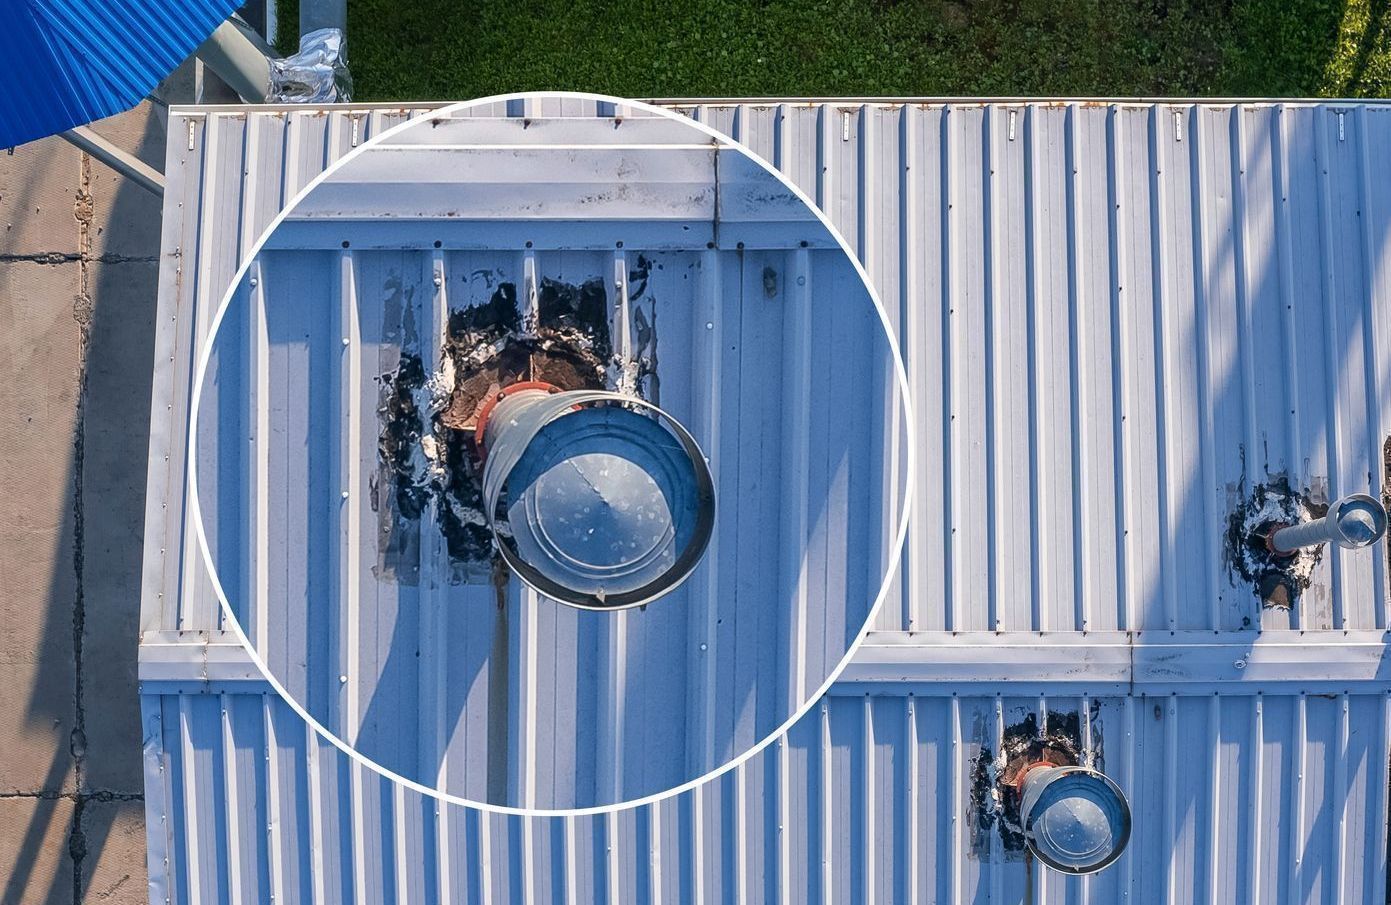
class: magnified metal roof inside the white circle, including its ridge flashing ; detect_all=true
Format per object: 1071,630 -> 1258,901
186,109 -> 901,809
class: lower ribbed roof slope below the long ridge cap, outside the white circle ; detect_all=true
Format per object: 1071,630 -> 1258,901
143,685 -> 1391,905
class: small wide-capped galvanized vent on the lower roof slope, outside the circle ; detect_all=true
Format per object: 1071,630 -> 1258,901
1020,762 -> 1131,873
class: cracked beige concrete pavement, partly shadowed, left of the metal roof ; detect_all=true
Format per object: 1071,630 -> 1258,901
0,79 -> 171,905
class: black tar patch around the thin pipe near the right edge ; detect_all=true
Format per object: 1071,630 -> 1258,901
1223,474 -> 1328,609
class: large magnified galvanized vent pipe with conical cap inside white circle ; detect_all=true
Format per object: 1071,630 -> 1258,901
477,382 -> 715,610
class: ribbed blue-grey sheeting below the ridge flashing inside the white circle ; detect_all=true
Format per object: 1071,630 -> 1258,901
199,239 -> 887,808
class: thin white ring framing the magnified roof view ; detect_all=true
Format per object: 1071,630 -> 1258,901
186,92 -> 917,817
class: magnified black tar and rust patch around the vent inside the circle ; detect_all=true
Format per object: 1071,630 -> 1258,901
373,264 -> 659,582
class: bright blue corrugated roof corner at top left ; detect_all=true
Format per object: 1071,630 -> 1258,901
0,0 -> 238,147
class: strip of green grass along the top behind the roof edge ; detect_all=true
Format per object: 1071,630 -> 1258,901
280,0 -> 1391,100
